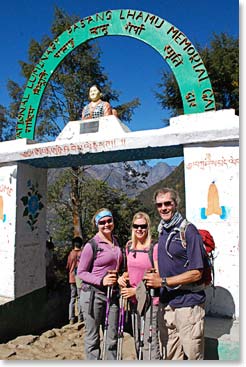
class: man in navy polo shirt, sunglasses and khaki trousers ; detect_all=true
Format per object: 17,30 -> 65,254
145,187 -> 206,360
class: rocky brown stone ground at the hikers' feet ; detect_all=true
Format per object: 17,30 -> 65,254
0,323 -> 136,360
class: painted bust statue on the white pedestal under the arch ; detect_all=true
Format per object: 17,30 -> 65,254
82,85 -> 113,120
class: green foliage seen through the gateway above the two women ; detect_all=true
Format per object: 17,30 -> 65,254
48,167 -> 142,246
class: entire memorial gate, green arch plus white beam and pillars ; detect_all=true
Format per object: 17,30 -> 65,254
0,10 -> 239,342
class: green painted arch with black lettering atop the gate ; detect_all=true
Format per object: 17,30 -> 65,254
16,9 -> 215,139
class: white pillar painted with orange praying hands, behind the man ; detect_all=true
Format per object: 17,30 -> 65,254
184,141 -> 239,317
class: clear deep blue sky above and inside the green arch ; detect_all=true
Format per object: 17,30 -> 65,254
0,0 -> 239,167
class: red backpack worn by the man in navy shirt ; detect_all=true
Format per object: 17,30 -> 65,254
179,219 -> 215,287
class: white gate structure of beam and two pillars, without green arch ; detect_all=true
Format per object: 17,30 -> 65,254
0,110 -> 239,344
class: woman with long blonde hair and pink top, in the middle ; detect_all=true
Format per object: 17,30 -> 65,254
118,212 -> 160,360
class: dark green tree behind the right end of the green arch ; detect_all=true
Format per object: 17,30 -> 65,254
156,33 -> 239,117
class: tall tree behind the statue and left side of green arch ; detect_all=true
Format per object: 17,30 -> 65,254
3,7 -> 140,237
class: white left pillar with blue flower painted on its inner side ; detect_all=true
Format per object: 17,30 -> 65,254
0,163 -> 47,299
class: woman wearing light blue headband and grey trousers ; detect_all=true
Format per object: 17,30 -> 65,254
78,208 -> 122,360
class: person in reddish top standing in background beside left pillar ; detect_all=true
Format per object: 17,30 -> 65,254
66,237 -> 83,325
